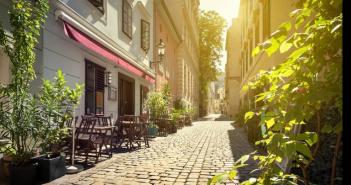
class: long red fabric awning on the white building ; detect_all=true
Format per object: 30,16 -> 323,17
63,21 -> 155,83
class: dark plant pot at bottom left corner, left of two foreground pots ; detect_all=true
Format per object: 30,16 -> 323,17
9,163 -> 38,185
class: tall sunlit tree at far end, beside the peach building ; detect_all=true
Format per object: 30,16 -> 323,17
199,11 -> 226,115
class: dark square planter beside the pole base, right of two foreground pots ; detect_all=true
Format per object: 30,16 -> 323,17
38,154 -> 66,182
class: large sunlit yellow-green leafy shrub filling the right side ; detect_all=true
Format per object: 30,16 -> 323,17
210,0 -> 343,184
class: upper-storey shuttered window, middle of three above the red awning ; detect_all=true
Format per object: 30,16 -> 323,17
122,0 -> 132,38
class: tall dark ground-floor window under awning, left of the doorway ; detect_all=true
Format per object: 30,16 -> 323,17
85,60 -> 105,114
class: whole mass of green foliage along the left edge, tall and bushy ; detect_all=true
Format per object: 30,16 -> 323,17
0,0 -> 81,165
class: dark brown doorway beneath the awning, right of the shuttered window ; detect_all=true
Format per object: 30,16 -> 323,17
118,73 -> 135,115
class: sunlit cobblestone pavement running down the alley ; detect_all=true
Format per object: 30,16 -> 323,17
50,114 -> 253,185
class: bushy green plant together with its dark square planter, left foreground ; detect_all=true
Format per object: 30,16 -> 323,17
38,70 -> 82,182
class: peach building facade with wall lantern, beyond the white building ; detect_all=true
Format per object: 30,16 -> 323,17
153,0 -> 200,116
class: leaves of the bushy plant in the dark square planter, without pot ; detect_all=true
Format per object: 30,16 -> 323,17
39,70 -> 83,152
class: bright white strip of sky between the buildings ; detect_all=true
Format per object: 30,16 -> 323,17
200,0 -> 240,71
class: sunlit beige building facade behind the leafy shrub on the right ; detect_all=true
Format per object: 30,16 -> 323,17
226,0 -> 296,116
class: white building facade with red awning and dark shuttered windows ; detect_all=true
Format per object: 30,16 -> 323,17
0,0 -> 155,118
